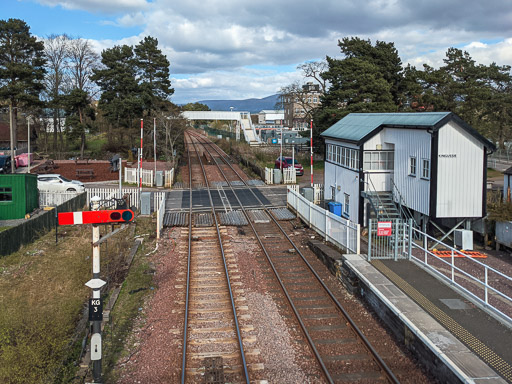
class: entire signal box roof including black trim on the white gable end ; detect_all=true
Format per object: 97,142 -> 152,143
321,112 -> 495,150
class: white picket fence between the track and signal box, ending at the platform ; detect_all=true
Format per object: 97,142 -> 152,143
287,188 -> 361,254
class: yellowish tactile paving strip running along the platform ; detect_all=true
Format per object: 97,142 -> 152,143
371,260 -> 512,381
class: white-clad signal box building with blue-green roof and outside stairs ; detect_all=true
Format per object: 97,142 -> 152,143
322,112 -> 495,228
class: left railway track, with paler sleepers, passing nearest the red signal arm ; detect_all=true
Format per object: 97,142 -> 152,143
181,134 -> 254,384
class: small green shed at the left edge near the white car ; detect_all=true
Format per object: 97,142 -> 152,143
0,173 -> 39,220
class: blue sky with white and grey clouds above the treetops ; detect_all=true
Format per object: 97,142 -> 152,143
4,0 -> 512,103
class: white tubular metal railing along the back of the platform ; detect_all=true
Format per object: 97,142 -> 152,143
403,222 -> 512,324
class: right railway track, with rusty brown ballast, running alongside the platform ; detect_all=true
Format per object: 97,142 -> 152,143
190,133 -> 398,383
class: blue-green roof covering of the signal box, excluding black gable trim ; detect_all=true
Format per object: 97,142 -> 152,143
321,112 -> 450,142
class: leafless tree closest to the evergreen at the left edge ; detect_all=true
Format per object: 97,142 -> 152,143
44,34 -> 70,151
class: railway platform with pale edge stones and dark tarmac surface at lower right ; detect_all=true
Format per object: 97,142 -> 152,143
342,255 -> 512,384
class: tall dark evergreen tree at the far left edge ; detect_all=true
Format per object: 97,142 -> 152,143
0,19 -> 45,145
